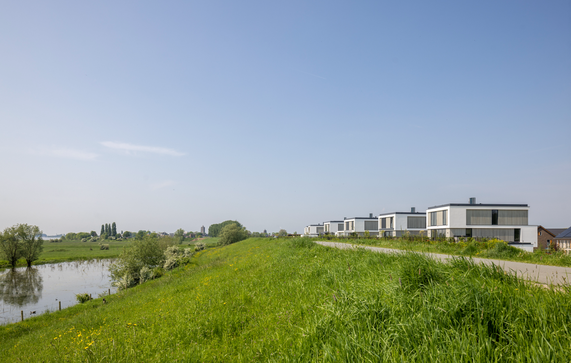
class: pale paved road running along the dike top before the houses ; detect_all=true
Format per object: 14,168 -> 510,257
316,241 -> 571,285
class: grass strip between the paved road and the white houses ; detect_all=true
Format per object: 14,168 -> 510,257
320,237 -> 571,267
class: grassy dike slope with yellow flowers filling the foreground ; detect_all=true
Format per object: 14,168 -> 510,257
0,239 -> 571,362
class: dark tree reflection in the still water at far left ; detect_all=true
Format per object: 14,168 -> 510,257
0,267 -> 44,307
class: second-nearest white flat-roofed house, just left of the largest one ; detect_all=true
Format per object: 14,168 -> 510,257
377,207 -> 426,237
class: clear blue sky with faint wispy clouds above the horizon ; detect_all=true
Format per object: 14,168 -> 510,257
0,0 -> 571,234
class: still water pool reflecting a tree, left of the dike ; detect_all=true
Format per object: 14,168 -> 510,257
0,260 -> 117,325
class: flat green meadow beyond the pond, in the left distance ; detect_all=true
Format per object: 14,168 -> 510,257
0,240 -> 131,268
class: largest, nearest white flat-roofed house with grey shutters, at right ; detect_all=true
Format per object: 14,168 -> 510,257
426,198 -> 537,252
